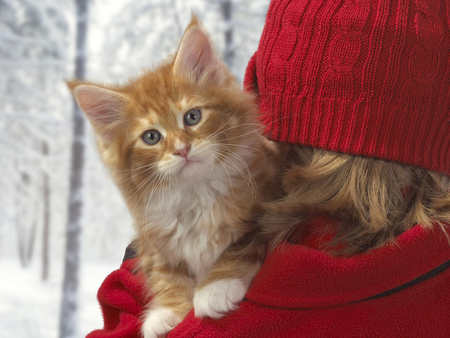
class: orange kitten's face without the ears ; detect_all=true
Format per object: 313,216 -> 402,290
125,78 -> 254,185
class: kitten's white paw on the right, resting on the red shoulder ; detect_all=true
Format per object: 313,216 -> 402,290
194,279 -> 247,318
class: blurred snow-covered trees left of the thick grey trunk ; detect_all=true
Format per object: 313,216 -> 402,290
0,0 -> 70,277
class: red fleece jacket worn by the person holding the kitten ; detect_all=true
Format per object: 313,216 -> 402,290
88,226 -> 450,338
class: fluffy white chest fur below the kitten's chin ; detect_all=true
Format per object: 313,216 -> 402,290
146,178 -> 236,279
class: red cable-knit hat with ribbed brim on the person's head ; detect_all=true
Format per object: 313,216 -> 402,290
244,0 -> 450,175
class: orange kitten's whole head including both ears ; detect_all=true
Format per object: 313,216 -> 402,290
68,17 -> 261,195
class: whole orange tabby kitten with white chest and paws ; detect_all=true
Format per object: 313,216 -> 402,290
68,17 -> 281,338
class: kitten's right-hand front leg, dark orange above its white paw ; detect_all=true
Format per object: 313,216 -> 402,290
193,236 -> 267,318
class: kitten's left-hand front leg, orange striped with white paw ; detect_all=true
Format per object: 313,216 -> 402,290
142,263 -> 195,338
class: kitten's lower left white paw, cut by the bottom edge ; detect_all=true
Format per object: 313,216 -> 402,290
142,307 -> 181,338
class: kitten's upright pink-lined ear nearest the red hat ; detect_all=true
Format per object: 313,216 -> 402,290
173,16 -> 228,85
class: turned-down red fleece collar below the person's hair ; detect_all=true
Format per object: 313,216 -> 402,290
246,225 -> 450,308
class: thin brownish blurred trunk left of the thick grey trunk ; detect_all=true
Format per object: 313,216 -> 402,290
41,141 -> 51,281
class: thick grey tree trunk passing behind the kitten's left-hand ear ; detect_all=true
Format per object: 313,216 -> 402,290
59,0 -> 89,338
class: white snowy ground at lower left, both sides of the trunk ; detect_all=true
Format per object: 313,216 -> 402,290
0,259 -> 120,338
